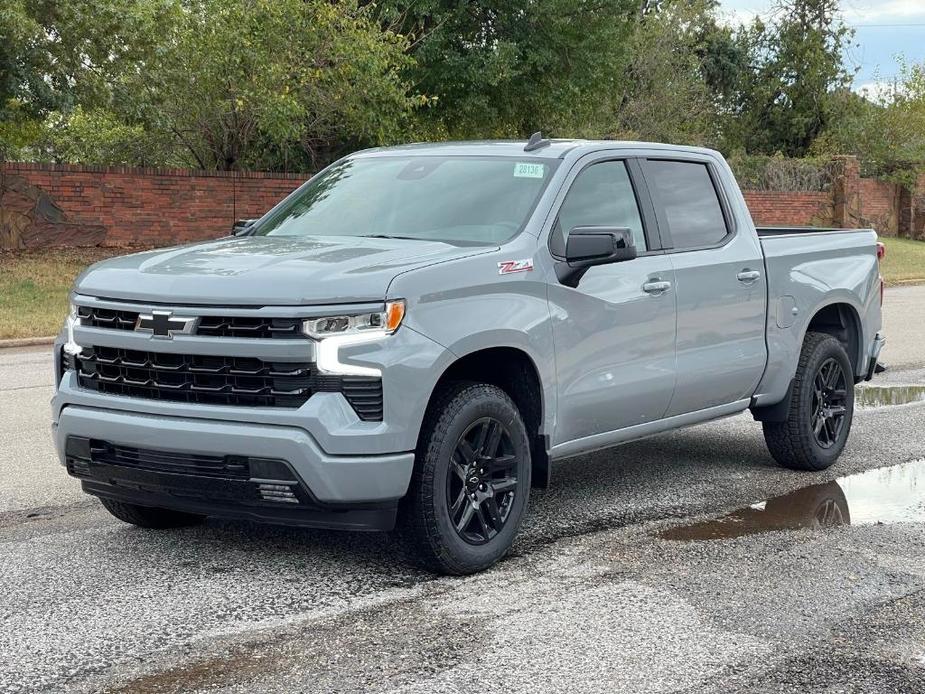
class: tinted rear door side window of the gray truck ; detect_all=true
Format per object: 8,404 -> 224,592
646,159 -> 729,249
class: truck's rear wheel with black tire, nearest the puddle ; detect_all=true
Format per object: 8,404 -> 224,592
763,332 -> 854,470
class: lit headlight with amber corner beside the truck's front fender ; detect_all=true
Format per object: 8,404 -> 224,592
302,299 -> 405,378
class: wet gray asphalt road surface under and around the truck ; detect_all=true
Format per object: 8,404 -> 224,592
0,287 -> 925,693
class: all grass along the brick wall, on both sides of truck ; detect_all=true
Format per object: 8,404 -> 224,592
0,238 -> 925,339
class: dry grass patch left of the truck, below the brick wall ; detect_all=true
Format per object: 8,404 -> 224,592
0,248 -> 134,339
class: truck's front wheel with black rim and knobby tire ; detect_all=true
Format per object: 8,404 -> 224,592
402,383 -> 531,575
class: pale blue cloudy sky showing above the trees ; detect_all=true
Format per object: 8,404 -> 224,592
720,0 -> 925,92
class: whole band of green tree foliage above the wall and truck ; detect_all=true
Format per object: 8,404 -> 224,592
0,0 -> 925,172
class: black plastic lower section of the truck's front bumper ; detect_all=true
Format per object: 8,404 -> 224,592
66,437 -> 398,531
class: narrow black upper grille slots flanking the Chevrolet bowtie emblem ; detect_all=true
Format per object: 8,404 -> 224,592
77,306 -> 308,339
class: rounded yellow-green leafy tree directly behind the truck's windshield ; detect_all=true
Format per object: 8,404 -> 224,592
125,0 -> 418,169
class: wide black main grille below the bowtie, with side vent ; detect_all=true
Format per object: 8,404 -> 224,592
77,347 -> 382,421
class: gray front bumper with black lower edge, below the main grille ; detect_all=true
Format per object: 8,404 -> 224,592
54,405 -> 414,529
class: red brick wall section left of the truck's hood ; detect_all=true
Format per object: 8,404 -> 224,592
0,163 -> 307,248
